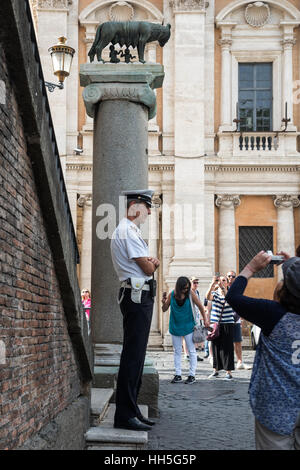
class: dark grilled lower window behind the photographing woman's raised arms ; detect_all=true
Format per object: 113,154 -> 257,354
239,226 -> 274,278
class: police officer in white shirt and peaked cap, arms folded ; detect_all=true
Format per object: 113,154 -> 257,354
111,190 -> 159,431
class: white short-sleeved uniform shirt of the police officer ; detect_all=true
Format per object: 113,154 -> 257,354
110,218 -> 151,281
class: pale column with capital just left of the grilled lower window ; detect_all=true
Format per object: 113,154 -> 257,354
216,194 -> 241,275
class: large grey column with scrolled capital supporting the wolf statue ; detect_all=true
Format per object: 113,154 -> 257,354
80,63 -> 164,343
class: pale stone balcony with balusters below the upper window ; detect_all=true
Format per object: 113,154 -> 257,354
217,131 -> 299,158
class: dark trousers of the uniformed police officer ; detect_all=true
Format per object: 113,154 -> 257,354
115,289 -> 153,424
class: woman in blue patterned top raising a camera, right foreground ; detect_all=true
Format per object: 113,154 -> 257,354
226,251 -> 300,450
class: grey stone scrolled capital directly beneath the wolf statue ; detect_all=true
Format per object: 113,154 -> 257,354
80,63 -> 164,119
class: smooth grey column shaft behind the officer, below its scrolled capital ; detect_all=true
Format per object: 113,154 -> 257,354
92,101 -> 148,343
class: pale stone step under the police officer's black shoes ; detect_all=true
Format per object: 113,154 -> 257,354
85,404 -> 148,450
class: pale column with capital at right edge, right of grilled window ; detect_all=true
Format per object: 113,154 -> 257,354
274,194 -> 300,256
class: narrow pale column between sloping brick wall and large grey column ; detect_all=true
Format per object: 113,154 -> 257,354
77,194 -> 93,295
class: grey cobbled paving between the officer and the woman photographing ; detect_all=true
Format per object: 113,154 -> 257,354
147,351 -> 255,450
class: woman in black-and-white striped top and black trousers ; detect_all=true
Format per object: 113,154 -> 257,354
206,275 -> 234,380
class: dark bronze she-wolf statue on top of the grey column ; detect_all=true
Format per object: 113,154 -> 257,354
88,21 -> 171,64
